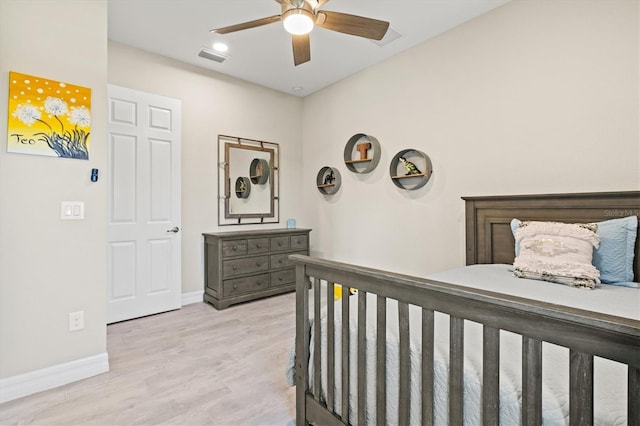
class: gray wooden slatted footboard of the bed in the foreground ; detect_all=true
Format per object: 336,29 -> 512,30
291,255 -> 640,425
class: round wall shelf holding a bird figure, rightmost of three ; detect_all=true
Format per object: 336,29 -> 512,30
389,148 -> 433,190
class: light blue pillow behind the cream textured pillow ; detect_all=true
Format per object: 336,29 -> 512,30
510,216 -> 638,288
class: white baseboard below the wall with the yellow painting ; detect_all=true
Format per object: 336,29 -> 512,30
0,352 -> 109,403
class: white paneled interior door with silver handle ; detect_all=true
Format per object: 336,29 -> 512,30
107,85 -> 182,323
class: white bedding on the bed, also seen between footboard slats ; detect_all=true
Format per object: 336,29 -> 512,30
288,265 -> 640,425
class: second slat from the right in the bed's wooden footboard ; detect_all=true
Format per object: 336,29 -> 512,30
569,350 -> 596,426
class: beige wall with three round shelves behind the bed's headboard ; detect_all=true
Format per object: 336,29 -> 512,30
303,0 -> 640,275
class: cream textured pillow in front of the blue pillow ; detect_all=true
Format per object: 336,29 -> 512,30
513,221 -> 600,289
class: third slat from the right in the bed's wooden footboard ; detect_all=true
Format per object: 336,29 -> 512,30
522,336 -> 542,425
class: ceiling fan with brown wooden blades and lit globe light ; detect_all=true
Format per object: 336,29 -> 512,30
211,0 -> 389,66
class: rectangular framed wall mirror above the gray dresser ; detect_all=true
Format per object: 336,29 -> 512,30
218,135 -> 280,225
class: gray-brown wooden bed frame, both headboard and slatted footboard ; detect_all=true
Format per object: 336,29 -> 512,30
291,191 -> 640,425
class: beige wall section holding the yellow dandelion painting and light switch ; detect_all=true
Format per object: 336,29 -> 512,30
0,0 -> 107,378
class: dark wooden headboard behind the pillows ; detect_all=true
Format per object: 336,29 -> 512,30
462,191 -> 640,281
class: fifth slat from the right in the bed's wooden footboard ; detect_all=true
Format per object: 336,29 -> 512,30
449,316 -> 464,425
